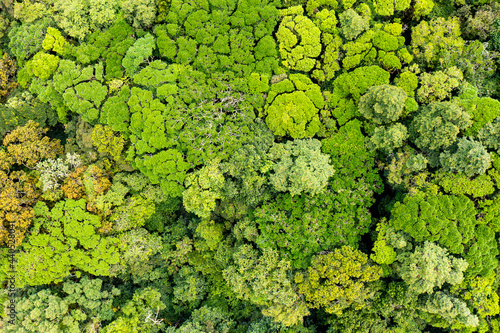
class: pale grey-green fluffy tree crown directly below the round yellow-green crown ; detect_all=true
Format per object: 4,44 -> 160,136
268,139 -> 334,196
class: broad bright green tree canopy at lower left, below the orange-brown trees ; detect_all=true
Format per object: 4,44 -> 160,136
16,199 -> 119,286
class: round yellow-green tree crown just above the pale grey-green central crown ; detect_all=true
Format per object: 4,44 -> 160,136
265,74 -> 325,139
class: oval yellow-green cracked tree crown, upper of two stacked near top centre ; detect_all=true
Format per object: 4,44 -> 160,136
276,15 -> 321,72
